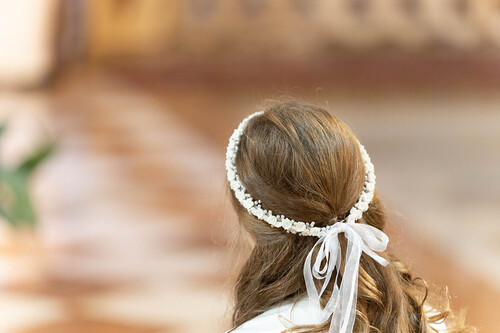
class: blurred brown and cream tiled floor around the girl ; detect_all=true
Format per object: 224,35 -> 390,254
0,64 -> 500,333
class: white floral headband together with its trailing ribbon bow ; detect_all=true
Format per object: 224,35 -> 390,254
226,111 -> 389,333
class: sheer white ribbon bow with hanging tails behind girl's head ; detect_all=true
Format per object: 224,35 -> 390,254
304,222 -> 389,333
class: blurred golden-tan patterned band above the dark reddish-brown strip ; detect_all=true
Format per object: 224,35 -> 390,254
88,0 -> 500,59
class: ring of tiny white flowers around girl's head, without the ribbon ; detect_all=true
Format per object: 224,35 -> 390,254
226,111 -> 376,237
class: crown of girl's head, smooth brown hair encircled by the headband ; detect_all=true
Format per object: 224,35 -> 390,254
232,102 -> 382,236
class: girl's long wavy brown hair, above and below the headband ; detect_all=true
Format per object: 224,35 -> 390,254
231,101 -> 473,333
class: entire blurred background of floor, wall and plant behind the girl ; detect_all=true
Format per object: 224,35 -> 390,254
0,0 -> 500,333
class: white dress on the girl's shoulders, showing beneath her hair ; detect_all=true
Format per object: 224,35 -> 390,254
226,299 -> 446,333
